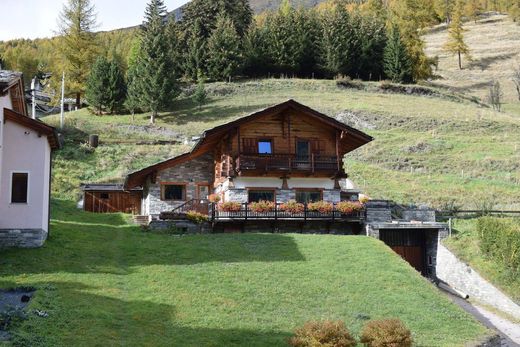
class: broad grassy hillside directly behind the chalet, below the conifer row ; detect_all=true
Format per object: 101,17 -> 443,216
47,79 -> 520,208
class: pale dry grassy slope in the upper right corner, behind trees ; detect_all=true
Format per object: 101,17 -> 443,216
425,15 -> 520,113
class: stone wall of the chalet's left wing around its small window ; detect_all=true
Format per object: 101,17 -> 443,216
147,153 -> 214,216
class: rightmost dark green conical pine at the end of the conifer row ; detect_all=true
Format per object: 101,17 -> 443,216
384,24 -> 412,83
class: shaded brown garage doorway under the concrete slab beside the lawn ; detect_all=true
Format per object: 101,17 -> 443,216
379,229 -> 426,275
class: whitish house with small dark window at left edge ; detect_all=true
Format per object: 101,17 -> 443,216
0,70 -> 60,248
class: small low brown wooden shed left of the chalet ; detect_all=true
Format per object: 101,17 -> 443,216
80,183 -> 143,215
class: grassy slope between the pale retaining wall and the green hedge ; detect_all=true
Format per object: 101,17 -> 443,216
444,219 -> 520,302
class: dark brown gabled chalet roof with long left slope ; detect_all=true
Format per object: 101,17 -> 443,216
124,99 -> 373,189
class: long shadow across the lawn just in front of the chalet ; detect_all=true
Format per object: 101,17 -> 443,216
0,200 -> 305,276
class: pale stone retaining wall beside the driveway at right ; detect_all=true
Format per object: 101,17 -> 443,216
437,245 -> 520,319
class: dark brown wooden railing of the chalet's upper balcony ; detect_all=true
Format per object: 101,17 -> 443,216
236,154 -> 341,172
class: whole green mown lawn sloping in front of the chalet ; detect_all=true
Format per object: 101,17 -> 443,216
0,201 -> 488,347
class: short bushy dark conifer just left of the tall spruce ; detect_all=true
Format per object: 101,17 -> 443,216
86,56 -> 110,114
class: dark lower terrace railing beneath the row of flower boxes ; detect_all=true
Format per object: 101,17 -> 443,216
210,203 -> 366,221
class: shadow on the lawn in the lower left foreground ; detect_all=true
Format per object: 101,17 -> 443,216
8,282 -> 289,346
